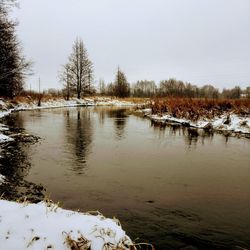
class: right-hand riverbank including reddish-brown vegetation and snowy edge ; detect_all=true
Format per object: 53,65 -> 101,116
137,98 -> 250,138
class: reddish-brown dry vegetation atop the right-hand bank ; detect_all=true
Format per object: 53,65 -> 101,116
150,98 -> 250,121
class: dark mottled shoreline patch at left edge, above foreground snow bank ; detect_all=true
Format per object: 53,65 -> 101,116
0,116 -> 46,203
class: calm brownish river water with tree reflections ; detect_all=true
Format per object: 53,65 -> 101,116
4,107 -> 250,249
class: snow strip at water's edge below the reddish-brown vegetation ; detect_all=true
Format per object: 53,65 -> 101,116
138,109 -> 250,135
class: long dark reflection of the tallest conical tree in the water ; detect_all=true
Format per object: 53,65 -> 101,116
64,108 -> 93,174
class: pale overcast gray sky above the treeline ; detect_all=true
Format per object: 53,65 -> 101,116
12,0 -> 250,89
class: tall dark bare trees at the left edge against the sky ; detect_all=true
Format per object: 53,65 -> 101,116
0,0 -> 30,98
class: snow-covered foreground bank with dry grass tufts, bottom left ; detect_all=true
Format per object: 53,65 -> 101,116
0,200 -> 136,250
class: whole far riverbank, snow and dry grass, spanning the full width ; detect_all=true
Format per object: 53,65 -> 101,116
0,97 -> 250,143
